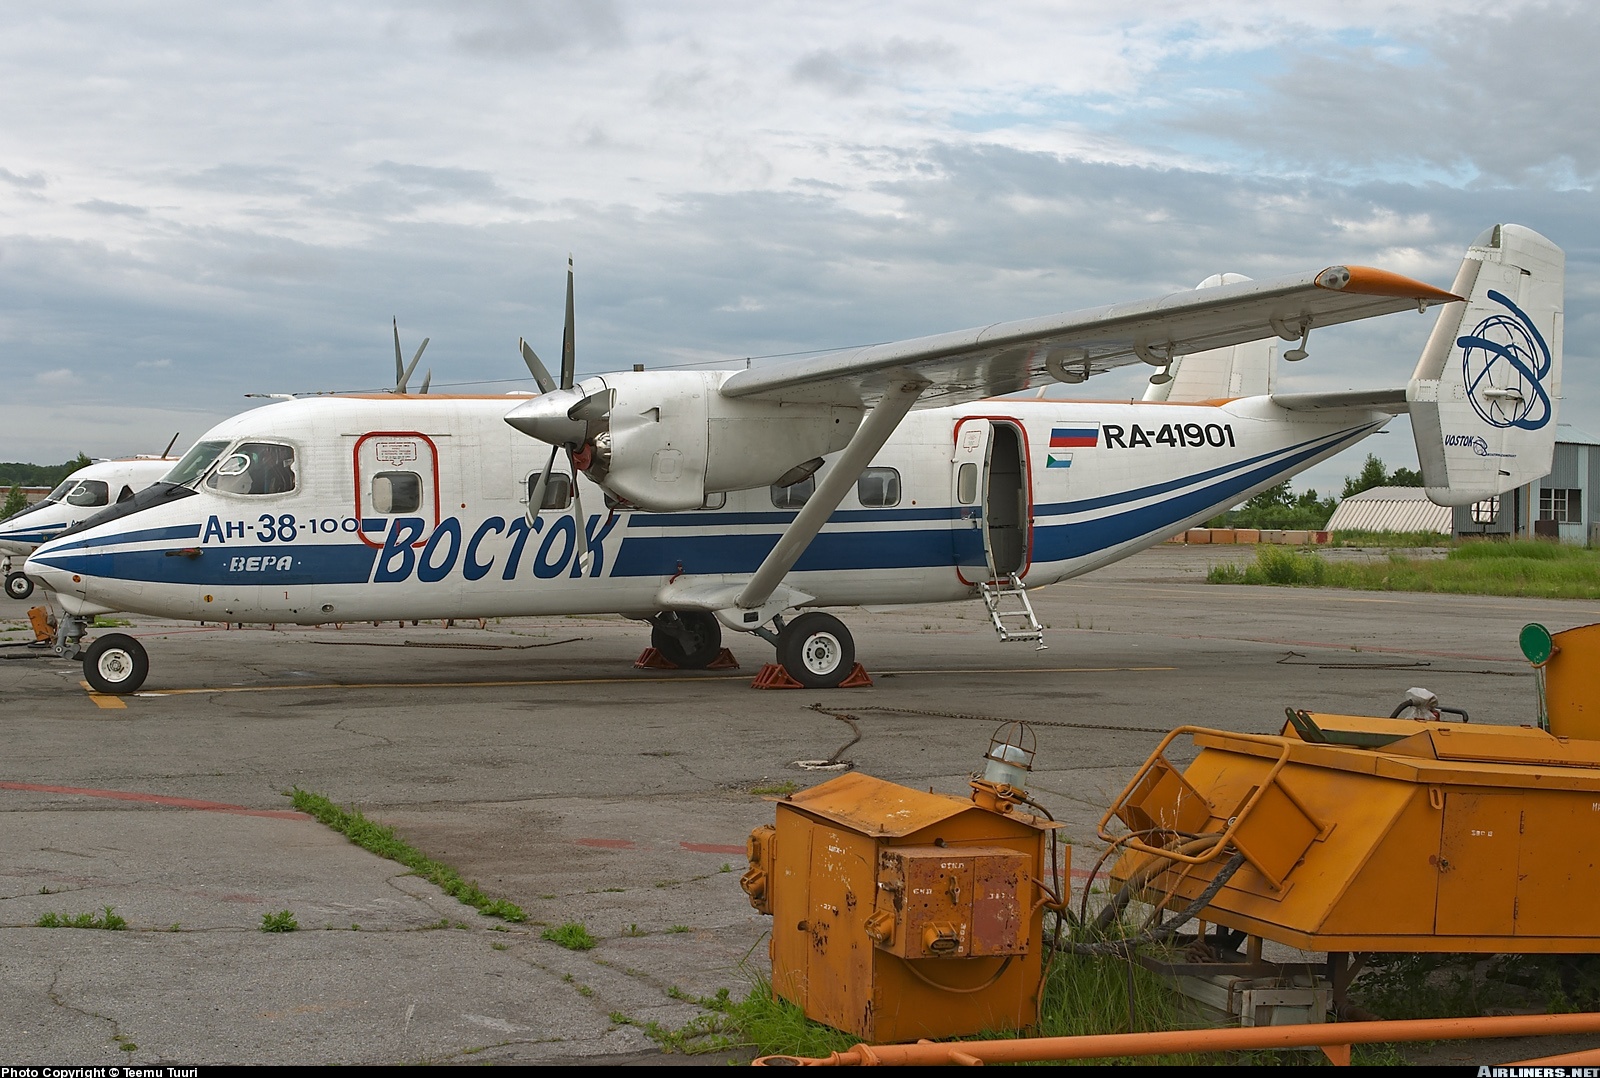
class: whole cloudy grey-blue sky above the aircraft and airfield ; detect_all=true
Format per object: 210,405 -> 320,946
0,0 -> 1600,489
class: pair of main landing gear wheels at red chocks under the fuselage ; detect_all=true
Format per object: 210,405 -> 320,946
650,609 -> 856,689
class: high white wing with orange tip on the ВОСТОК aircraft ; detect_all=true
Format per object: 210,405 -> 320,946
722,266 -> 1461,408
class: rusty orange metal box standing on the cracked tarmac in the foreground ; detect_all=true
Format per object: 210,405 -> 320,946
742,774 -> 1054,1043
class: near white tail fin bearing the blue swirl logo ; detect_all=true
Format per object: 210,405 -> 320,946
1406,224 -> 1566,505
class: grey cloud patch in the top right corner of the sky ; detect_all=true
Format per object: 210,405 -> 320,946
1171,5 -> 1600,186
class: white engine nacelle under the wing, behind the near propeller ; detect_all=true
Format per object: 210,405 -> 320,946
592,371 -> 864,512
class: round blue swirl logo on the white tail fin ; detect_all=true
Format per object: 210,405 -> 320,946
1456,289 -> 1552,430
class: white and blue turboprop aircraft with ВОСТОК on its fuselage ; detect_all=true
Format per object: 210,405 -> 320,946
27,226 -> 1563,693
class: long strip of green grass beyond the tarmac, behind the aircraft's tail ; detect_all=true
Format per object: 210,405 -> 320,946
1206,539 -> 1600,600
